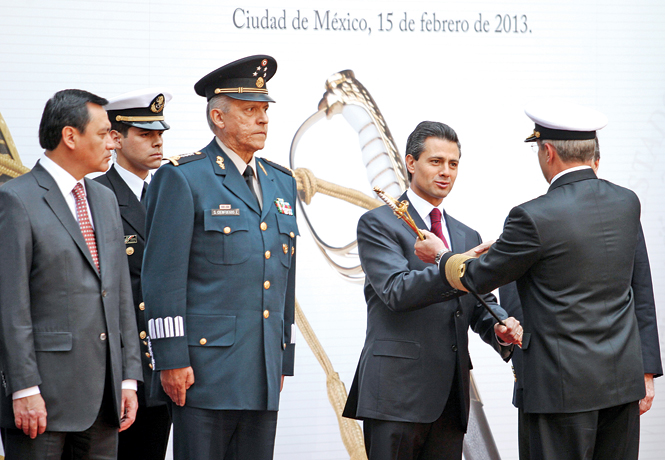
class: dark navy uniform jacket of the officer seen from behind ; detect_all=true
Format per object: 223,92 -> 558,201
442,169 -> 644,413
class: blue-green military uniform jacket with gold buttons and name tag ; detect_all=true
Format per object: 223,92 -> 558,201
142,139 -> 298,411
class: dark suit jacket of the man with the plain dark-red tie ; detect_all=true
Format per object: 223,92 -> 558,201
344,193 -> 510,429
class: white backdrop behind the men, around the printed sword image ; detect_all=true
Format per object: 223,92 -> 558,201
0,0 -> 665,460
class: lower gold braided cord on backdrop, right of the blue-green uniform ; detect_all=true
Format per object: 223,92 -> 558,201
296,300 -> 367,460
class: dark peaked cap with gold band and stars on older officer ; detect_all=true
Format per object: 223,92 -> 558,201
194,54 -> 277,102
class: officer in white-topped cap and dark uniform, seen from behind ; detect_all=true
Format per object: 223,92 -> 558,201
416,103 -> 645,460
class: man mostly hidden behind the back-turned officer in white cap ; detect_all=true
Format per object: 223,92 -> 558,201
499,145 -> 663,460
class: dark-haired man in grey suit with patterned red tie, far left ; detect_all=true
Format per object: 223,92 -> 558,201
0,90 -> 142,460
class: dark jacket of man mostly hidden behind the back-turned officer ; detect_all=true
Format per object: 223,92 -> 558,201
499,227 -> 663,409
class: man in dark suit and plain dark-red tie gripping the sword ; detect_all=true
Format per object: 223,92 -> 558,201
344,122 -> 521,460
